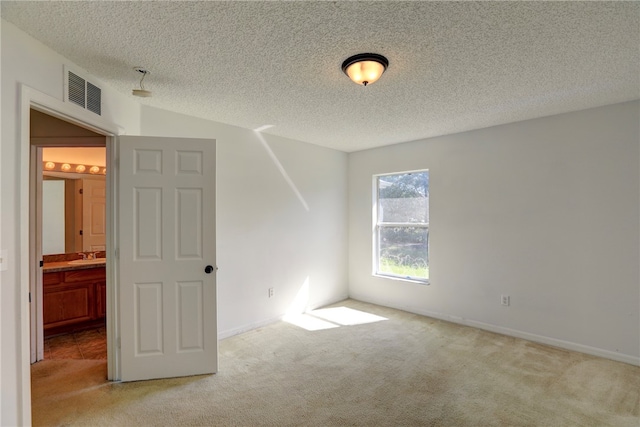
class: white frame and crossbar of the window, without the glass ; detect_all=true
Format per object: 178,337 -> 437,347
372,169 -> 431,285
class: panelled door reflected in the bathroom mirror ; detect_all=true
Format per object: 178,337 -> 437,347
82,178 -> 107,252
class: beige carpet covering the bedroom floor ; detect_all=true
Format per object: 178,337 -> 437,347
32,300 -> 640,427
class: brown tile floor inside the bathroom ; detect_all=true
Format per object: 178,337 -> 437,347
44,327 -> 107,360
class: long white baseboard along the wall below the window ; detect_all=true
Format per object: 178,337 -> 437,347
351,295 -> 640,366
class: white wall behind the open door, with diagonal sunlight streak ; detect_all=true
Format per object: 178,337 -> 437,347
141,107 -> 347,337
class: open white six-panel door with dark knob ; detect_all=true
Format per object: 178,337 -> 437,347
118,137 -> 218,381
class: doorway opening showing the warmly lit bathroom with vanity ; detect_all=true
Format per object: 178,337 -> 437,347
30,109 -> 107,365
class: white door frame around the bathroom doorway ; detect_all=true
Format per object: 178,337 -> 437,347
17,84 -> 125,425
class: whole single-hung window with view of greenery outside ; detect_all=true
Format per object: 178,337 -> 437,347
374,171 -> 429,283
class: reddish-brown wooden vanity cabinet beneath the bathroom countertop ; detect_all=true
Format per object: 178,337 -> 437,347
42,267 -> 107,337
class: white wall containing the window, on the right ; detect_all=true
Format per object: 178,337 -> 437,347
349,101 -> 640,364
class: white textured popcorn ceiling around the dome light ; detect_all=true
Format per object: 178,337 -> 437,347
0,1 -> 640,152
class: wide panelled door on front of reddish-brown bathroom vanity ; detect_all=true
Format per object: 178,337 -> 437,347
43,283 -> 95,330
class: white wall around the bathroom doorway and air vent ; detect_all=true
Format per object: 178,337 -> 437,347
0,20 -> 140,426
